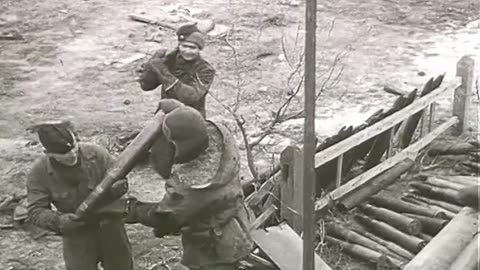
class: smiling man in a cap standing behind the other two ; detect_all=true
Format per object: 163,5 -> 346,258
139,24 -> 215,118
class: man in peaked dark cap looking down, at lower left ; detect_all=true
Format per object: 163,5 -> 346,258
27,122 -> 133,270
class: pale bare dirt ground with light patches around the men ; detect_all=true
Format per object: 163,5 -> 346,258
0,0 -> 480,270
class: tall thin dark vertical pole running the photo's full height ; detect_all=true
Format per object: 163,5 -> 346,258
302,0 -> 317,270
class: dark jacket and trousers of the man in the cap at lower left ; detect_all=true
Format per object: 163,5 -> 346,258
27,143 -> 133,270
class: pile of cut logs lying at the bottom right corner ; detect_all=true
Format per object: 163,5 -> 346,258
325,175 -> 480,270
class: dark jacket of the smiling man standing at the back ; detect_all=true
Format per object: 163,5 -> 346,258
140,50 -> 215,117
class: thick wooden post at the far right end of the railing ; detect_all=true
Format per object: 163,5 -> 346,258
453,55 -> 475,136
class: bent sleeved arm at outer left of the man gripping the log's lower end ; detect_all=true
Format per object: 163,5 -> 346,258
27,169 -> 59,232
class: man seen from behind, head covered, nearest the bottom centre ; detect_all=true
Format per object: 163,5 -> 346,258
127,99 -> 253,270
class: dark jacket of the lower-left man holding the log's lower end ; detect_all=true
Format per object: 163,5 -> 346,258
27,143 -> 120,231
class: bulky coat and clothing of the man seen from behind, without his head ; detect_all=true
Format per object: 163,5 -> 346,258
127,99 -> 253,270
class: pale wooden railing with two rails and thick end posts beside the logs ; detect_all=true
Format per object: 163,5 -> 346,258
281,56 -> 474,226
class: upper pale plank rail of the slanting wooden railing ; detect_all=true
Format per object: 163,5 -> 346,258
315,85 -> 456,168
